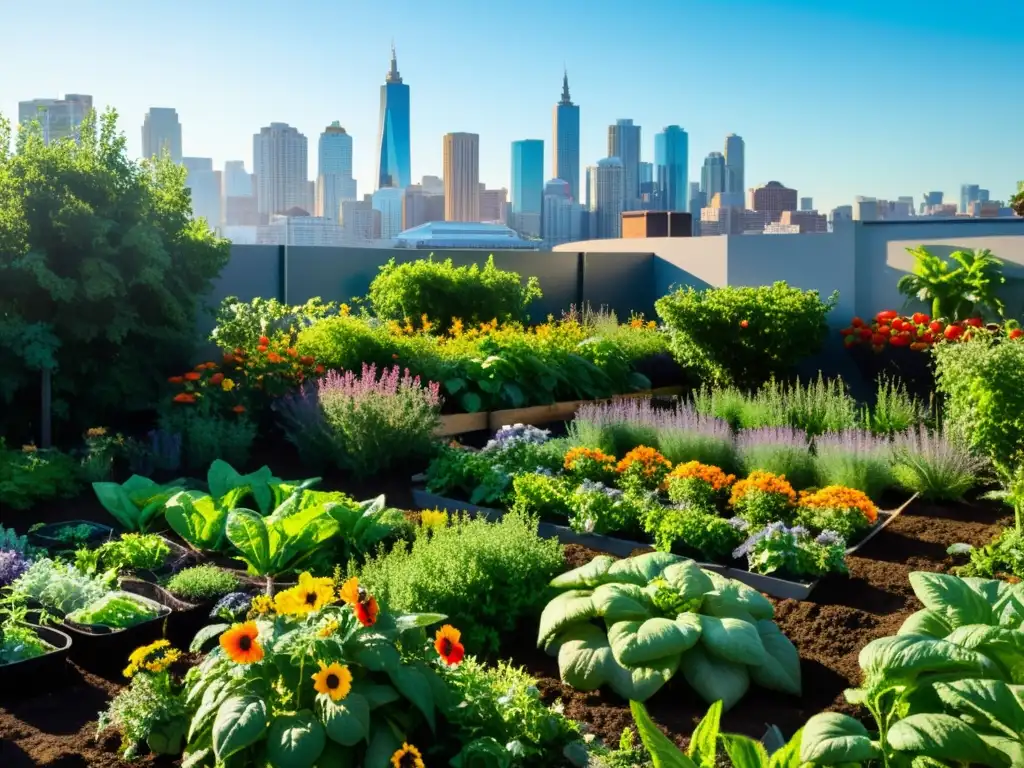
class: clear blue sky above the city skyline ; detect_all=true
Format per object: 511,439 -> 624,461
0,0 -> 1024,210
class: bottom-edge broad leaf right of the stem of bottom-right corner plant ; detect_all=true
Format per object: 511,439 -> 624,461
887,714 -> 1010,766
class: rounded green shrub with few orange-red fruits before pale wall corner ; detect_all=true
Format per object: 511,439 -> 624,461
655,283 -> 838,386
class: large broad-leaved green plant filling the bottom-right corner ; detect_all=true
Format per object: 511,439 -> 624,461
801,572 -> 1024,766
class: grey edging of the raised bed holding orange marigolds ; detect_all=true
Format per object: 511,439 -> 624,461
413,487 -> 918,600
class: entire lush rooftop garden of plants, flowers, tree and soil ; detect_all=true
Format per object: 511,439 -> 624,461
0,116 -> 1024,768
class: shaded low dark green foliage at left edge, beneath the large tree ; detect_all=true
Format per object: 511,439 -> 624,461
0,437 -> 81,509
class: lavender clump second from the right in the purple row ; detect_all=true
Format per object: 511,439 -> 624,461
814,429 -> 893,499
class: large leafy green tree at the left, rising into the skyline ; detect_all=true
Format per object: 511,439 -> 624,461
0,111 -> 229,436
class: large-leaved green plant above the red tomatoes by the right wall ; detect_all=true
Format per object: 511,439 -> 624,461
896,246 -> 1007,323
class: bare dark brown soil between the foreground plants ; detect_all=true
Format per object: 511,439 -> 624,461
0,494 -> 1005,768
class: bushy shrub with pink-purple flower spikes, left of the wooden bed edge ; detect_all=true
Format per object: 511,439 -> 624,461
276,366 -> 440,477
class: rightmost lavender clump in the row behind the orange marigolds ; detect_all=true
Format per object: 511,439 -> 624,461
892,425 -> 988,501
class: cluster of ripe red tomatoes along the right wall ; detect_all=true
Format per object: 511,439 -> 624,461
841,309 -> 1024,352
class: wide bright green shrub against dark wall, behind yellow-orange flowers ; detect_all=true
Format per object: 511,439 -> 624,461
368,254 -> 542,331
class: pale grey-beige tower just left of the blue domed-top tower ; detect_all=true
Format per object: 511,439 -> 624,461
253,123 -> 312,221
